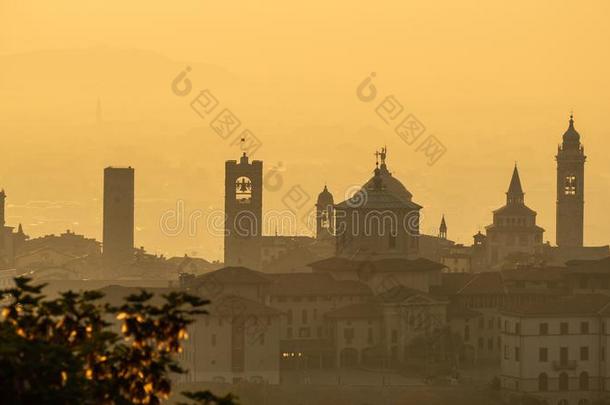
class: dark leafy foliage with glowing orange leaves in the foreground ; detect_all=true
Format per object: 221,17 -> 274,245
0,278 -> 235,405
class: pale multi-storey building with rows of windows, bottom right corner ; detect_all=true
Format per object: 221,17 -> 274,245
501,294 -> 610,405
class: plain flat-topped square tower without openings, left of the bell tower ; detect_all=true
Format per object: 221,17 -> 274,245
103,167 -> 134,268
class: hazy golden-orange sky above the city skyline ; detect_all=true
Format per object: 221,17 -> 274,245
0,0 -> 610,258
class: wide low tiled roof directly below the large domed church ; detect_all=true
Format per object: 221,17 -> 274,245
309,256 -> 447,272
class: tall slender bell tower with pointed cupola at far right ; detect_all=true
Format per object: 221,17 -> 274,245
555,115 -> 587,247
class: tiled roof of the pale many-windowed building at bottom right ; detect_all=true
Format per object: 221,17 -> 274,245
502,294 -> 610,317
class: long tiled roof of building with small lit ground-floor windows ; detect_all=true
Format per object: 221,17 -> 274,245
267,273 -> 372,296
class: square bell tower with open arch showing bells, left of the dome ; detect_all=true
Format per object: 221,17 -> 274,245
225,152 -> 263,270
